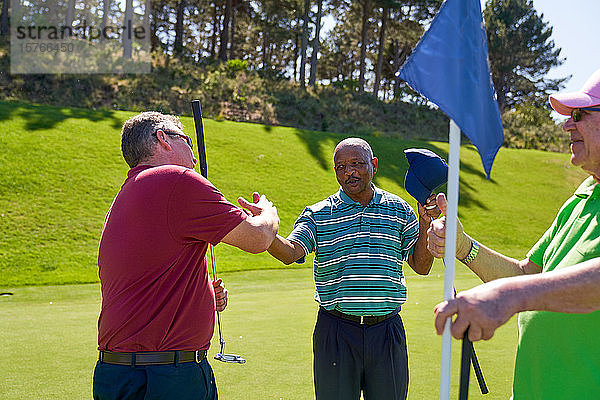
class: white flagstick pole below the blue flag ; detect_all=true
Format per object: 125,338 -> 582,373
440,119 -> 460,400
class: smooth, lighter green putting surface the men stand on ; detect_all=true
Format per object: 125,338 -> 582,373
0,263 -> 516,400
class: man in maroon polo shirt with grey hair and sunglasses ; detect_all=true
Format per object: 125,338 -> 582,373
93,112 -> 279,400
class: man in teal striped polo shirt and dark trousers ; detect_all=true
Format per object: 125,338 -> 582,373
268,138 -> 439,400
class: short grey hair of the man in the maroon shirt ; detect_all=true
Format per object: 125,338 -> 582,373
121,111 -> 183,168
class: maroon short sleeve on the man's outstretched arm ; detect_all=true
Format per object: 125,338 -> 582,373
168,170 -> 246,245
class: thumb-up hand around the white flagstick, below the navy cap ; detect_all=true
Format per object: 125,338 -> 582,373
427,193 -> 471,259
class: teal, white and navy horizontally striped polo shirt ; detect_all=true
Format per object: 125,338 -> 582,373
288,186 -> 419,315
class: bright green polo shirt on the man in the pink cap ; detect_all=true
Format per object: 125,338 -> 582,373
513,177 -> 600,400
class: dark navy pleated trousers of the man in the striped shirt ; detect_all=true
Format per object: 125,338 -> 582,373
313,309 -> 408,400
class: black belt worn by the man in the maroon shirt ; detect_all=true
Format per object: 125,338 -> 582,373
100,350 -> 206,367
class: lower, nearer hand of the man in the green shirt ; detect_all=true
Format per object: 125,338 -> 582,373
434,280 -> 519,342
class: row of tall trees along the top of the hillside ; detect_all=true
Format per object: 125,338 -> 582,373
0,0 -> 566,111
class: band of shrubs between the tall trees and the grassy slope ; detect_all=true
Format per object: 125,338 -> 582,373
0,38 -> 568,151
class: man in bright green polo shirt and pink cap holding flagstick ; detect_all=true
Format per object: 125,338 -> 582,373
428,70 -> 600,400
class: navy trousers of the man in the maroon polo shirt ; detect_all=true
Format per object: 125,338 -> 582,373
94,360 -> 218,400
